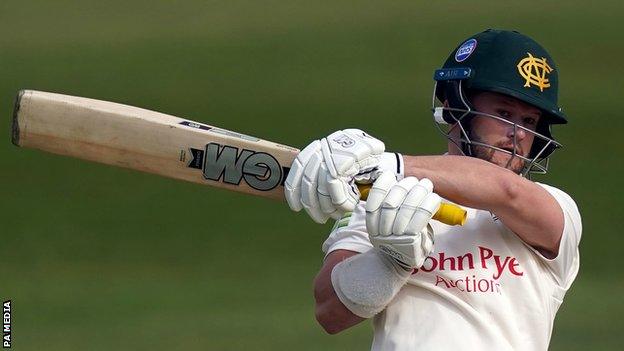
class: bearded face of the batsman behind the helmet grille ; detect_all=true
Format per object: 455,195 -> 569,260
470,92 -> 541,173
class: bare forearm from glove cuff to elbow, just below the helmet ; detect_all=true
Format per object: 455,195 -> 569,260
403,155 -> 519,211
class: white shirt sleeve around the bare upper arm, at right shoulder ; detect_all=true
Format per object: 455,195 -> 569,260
531,183 -> 583,290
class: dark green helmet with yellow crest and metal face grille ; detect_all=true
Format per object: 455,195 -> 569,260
434,29 -> 567,174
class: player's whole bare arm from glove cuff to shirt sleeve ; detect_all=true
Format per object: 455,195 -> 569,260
404,155 -> 564,257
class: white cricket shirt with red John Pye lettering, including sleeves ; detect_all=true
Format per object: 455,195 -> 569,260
323,183 -> 582,351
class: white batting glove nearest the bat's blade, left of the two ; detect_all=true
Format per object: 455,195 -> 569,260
284,129 -> 385,223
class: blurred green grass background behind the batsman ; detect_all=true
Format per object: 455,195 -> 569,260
0,0 -> 624,350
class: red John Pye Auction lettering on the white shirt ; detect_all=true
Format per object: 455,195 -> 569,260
412,246 -> 524,294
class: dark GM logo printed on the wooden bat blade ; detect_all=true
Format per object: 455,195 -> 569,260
188,143 -> 290,191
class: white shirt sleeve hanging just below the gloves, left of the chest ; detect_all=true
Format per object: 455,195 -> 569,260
322,201 -> 373,257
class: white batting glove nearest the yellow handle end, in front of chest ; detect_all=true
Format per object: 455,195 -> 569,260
366,172 -> 441,270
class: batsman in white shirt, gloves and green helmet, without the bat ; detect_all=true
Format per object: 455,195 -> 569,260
285,30 -> 582,350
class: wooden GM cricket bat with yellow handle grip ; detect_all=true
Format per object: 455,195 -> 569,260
12,90 -> 466,225
